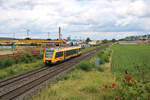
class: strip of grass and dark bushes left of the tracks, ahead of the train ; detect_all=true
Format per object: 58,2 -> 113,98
0,53 -> 43,79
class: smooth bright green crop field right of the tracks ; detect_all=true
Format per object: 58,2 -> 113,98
112,45 -> 150,79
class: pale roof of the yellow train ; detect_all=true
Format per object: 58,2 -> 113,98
47,46 -> 81,51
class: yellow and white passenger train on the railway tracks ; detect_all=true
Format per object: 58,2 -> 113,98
43,46 -> 82,65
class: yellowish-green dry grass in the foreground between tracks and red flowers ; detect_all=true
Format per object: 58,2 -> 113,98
32,68 -> 115,100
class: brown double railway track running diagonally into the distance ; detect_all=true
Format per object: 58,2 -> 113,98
0,45 -> 108,100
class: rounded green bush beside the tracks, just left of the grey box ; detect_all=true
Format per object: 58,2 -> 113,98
77,61 -> 92,71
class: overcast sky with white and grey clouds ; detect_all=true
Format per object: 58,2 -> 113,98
0,0 -> 150,39
